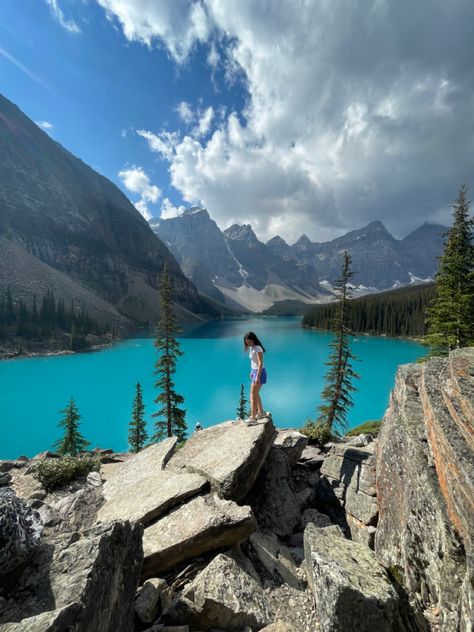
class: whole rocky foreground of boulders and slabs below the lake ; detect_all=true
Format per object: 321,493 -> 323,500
0,349 -> 474,632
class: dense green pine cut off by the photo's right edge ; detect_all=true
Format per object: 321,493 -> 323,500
424,185 -> 474,355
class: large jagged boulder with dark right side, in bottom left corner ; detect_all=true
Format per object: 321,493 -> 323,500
0,522 -> 143,632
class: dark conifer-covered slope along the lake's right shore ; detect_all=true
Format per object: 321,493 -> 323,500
303,283 -> 435,336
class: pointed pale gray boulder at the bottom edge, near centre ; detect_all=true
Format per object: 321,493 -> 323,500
168,554 -> 274,632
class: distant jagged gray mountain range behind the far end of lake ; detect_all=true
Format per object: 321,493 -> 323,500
150,207 -> 446,312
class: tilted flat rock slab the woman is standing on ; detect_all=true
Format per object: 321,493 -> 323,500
167,419 -> 277,501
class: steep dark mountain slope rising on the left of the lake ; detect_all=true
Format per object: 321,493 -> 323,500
0,95 -> 218,328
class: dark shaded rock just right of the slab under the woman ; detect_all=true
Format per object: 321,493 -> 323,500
247,447 -> 301,537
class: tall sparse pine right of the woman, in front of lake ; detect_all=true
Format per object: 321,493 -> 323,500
317,251 -> 359,432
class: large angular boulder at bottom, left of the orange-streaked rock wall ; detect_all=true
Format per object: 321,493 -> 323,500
304,523 -> 418,632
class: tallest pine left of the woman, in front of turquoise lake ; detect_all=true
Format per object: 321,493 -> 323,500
152,264 -> 187,442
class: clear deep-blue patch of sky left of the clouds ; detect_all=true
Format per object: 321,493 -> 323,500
0,0 -> 245,215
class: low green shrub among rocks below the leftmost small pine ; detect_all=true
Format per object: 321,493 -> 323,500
33,456 -> 100,493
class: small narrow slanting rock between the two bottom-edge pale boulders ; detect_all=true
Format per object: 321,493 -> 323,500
250,531 -> 301,588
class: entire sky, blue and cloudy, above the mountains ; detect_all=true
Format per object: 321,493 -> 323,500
0,0 -> 474,243
